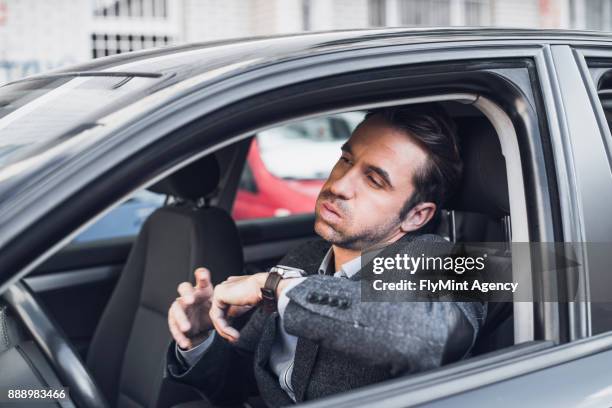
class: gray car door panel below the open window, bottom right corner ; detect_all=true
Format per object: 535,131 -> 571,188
298,333 -> 612,408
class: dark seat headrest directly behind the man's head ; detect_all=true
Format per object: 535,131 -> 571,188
445,118 -> 510,218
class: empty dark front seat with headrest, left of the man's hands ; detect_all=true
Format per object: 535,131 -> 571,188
87,157 -> 243,407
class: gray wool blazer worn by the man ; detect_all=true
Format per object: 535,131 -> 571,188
167,234 -> 486,407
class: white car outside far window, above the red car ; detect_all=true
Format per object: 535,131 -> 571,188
257,112 -> 364,180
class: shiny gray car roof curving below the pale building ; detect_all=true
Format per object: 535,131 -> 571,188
10,27 -> 612,85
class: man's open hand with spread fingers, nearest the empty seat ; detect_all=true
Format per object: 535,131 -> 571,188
168,268 -> 213,349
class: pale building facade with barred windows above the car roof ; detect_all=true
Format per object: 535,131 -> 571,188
0,0 -> 612,84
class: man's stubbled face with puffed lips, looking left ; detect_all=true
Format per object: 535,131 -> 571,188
315,116 -> 427,250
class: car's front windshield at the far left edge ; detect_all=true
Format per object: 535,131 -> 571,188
0,75 -> 159,169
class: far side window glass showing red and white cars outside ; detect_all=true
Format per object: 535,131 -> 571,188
233,112 -> 364,220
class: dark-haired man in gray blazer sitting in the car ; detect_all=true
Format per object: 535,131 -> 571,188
167,104 -> 485,406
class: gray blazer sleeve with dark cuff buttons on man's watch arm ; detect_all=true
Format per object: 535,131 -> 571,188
283,276 -> 484,372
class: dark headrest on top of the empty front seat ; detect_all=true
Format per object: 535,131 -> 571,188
149,155 -> 221,201
